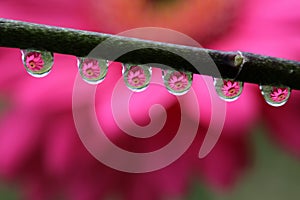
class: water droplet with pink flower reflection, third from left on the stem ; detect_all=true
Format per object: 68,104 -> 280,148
122,64 -> 152,92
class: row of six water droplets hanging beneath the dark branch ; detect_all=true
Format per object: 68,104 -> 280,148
21,49 -> 291,107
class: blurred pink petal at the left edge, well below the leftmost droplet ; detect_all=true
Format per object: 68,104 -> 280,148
0,108 -> 43,178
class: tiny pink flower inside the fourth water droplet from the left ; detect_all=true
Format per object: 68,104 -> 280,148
168,72 -> 188,91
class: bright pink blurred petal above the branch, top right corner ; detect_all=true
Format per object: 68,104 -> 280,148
209,0 -> 300,60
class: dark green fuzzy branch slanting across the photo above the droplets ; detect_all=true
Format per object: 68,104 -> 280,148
0,19 -> 300,90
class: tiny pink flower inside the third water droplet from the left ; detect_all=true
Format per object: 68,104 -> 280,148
127,66 -> 146,87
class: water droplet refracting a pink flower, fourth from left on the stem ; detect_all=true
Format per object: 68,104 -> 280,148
162,69 -> 193,96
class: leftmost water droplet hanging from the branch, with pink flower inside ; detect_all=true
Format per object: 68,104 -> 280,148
21,49 -> 53,78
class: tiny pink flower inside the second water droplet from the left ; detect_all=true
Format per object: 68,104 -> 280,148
82,59 -> 100,79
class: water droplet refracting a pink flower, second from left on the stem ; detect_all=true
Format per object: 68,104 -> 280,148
77,58 -> 108,84
